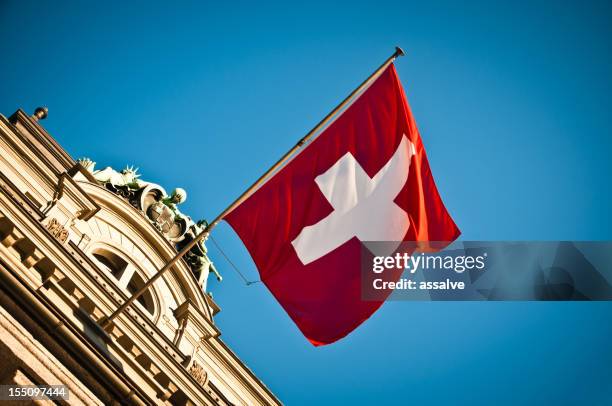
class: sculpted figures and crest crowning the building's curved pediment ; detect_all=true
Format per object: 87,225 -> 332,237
78,158 -> 222,290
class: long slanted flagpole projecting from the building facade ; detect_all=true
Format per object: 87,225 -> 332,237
99,47 -> 404,329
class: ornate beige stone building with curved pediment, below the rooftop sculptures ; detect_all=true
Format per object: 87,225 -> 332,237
0,109 -> 280,405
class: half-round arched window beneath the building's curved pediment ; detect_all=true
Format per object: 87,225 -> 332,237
92,248 -> 155,315
